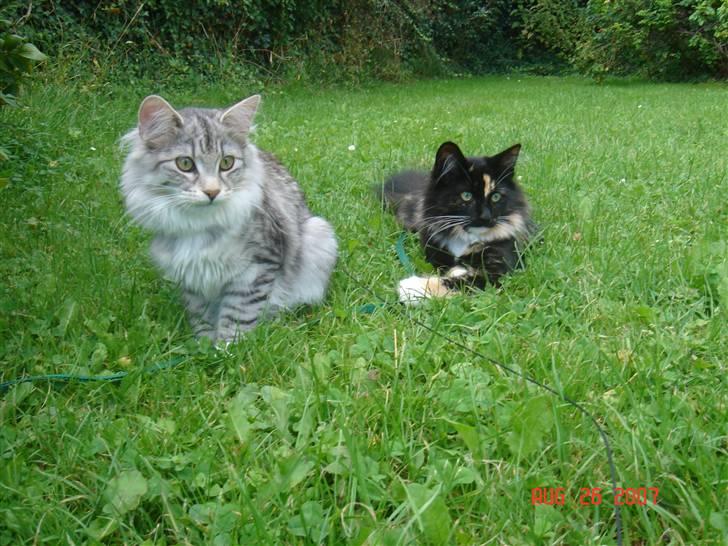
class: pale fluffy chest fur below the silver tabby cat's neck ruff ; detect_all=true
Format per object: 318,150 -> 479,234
152,232 -> 256,299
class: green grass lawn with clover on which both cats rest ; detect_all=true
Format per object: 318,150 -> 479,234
0,77 -> 728,545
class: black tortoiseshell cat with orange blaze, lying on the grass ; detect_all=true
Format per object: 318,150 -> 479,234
382,142 -> 536,288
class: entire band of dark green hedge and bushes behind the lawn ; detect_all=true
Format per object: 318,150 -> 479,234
0,0 -> 728,82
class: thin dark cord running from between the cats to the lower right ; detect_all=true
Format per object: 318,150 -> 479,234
339,266 -> 622,546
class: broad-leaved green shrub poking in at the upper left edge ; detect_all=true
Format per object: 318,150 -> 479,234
0,19 -> 46,106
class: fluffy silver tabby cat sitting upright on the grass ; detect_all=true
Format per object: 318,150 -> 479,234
121,95 -> 337,342
